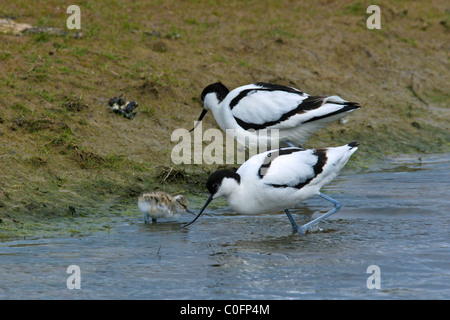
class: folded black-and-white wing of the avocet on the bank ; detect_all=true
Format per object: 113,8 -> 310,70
224,82 -> 359,130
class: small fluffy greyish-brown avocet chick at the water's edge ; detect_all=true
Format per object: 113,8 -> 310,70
138,191 -> 194,223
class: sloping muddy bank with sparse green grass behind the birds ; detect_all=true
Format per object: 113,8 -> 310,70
0,0 -> 450,238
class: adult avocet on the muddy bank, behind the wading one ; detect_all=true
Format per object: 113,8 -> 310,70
191,82 -> 360,150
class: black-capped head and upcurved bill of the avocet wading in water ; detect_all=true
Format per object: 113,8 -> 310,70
184,170 -> 241,227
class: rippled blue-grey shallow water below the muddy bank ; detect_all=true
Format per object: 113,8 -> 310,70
0,155 -> 450,299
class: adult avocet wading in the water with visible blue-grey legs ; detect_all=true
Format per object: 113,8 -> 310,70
184,142 -> 358,234
